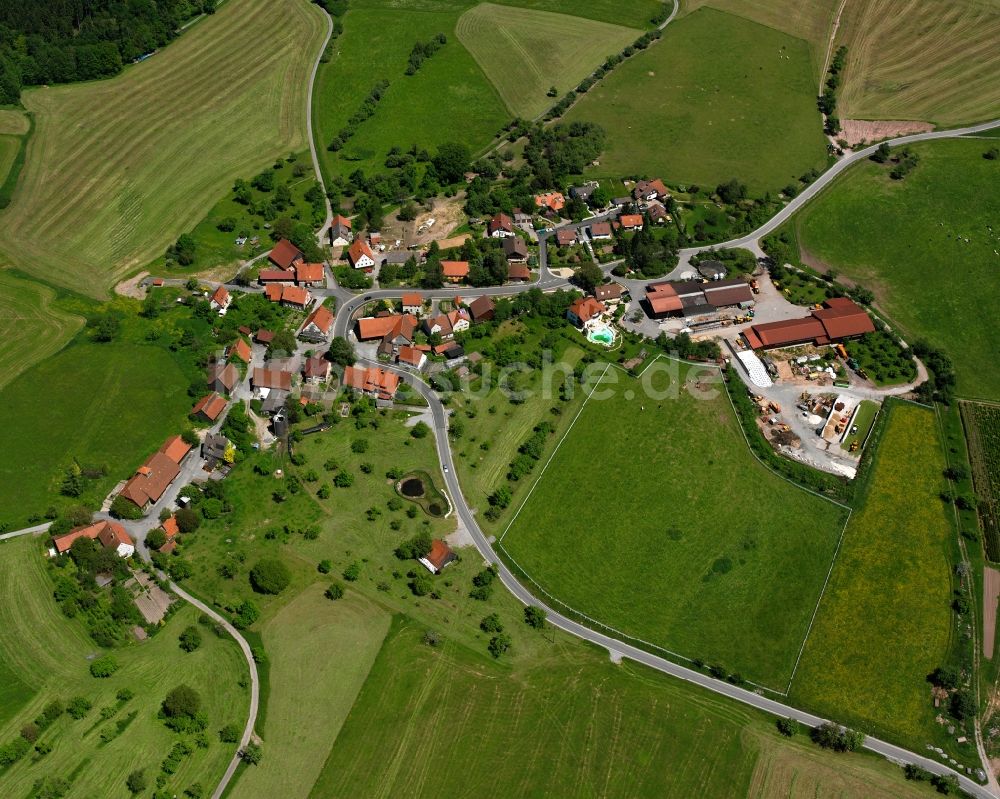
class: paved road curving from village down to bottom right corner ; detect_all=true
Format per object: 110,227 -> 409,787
361,360 -> 996,799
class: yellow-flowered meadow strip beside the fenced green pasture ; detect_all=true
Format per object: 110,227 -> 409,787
791,404 -> 955,751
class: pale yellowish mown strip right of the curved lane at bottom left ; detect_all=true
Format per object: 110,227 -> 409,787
229,583 -> 391,799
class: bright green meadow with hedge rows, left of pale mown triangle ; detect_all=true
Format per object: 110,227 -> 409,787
313,2 -> 509,181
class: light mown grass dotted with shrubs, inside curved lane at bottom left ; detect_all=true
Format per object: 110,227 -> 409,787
0,536 -> 249,799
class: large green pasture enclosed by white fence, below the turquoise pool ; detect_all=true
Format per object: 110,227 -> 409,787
501,361 -> 845,691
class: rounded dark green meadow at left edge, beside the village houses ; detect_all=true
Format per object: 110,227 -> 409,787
0,335 -> 191,529
